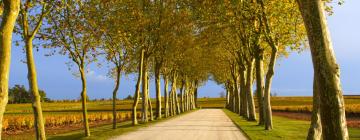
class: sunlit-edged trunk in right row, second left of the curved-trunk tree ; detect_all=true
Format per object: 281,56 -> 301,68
246,59 -> 256,121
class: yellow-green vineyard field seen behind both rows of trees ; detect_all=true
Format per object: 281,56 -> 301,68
3,96 -> 360,139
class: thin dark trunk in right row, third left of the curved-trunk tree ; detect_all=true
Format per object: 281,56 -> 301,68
239,69 -> 249,119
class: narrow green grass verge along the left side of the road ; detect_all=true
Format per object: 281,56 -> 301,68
48,110 -> 196,140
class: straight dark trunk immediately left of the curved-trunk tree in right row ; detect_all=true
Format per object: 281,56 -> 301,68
255,46 -> 265,125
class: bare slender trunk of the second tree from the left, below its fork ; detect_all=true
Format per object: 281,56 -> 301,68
25,38 -> 46,140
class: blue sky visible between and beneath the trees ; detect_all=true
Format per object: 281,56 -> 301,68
9,0 -> 360,99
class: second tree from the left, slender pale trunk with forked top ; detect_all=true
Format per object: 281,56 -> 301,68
19,0 -> 51,140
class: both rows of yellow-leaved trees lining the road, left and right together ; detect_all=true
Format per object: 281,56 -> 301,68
0,0 -> 348,139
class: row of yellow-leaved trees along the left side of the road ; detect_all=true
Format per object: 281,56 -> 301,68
0,0 -> 207,139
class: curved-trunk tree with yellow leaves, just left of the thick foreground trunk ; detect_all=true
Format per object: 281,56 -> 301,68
257,0 -> 305,130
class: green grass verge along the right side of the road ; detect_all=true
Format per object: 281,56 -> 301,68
223,109 -> 360,140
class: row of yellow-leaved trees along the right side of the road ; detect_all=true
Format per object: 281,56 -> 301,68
197,0 -> 348,139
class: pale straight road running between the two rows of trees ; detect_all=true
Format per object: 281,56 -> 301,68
113,109 -> 247,140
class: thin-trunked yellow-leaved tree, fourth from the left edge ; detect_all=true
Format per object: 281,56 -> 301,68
86,0 -> 133,129
